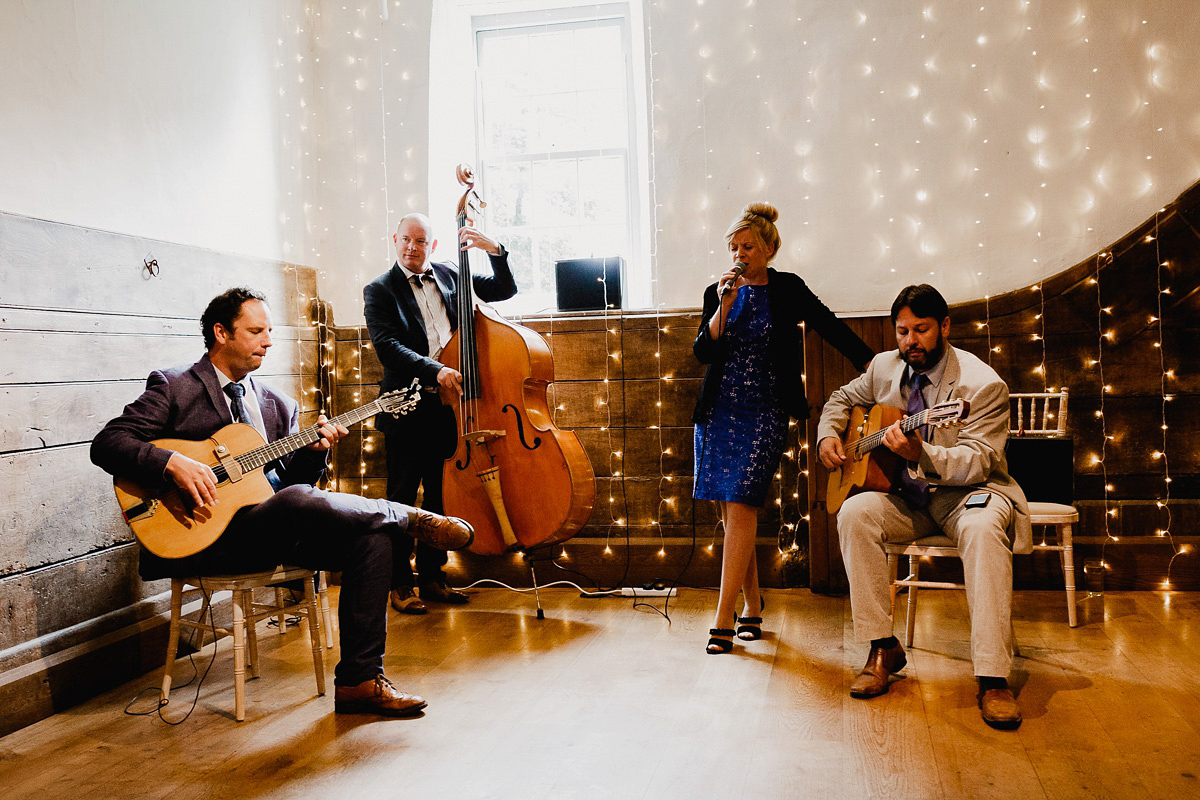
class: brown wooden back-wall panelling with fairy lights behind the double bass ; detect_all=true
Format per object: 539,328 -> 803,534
334,312 -> 739,582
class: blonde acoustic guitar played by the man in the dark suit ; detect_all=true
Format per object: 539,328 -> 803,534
113,379 -> 419,559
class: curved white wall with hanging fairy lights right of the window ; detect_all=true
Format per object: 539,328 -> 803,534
649,0 -> 1200,311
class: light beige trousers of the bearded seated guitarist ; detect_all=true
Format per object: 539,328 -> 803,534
838,486 -> 1013,678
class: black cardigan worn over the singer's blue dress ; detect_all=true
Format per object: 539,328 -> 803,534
691,267 -> 875,422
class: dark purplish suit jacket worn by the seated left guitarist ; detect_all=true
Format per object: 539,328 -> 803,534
91,355 -> 326,578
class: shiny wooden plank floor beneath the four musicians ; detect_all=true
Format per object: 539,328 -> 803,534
0,589 -> 1200,800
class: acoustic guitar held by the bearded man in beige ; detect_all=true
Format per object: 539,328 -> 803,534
826,399 -> 971,513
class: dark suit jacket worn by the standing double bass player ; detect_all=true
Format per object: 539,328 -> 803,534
362,247 -> 517,434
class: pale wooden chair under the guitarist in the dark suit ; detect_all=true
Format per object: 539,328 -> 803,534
160,566 -> 328,722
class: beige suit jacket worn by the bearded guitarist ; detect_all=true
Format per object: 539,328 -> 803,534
817,347 -> 1033,553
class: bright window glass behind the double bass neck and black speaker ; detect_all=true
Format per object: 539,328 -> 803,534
478,13 -> 632,311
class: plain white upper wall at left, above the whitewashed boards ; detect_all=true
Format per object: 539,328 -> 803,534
0,0 -> 314,272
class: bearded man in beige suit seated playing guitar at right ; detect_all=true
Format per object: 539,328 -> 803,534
817,284 -> 1033,729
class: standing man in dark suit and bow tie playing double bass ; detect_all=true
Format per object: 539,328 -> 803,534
362,213 -> 517,614
